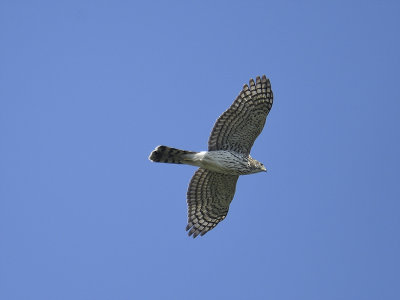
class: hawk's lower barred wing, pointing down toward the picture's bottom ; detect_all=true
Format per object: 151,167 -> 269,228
186,168 -> 239,238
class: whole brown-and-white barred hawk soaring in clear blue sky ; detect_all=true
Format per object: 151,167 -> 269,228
149,75 -> 273,238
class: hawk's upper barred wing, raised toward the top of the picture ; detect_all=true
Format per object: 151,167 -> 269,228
208,75 -> 273,155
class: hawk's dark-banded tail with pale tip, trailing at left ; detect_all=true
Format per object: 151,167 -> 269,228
149,146 -> 197,164
